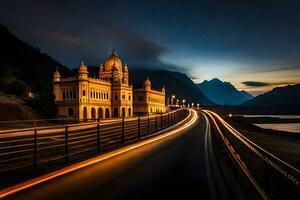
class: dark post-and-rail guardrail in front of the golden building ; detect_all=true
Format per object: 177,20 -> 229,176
0,109 -> 189,173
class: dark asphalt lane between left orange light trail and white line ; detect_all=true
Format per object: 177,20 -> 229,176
9,111 -> 210,200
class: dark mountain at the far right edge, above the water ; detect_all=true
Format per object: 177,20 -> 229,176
243,84 -> 300,107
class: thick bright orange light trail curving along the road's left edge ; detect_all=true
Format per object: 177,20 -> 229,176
0,109 -> 198,198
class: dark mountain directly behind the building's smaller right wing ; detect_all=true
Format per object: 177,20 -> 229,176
129,69 -> 213,105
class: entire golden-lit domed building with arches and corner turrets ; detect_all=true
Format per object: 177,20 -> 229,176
53,50 -> 166,119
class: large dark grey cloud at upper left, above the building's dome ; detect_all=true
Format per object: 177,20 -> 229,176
0,1 -> 168,67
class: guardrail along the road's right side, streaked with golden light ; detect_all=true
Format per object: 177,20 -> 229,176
204,110 -> 300,199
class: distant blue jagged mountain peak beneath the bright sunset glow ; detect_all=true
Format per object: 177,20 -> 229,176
197,78 -> 253,105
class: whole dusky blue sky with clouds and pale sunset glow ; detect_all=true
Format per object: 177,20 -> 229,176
0,0 -> 300,95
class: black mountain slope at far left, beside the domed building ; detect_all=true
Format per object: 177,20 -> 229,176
0,25 -> 72,117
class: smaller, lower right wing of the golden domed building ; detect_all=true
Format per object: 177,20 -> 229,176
133,78 -> 166,115
